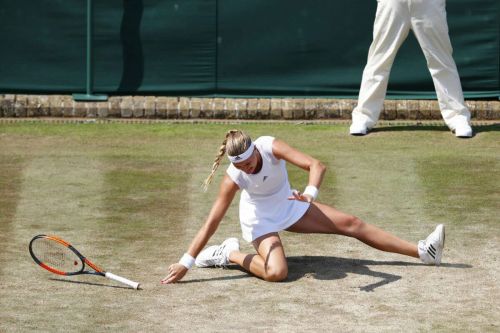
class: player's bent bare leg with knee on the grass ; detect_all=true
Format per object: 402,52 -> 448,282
229,233 -> 288,282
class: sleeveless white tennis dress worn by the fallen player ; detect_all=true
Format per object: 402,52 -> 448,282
226,136 -> 310,242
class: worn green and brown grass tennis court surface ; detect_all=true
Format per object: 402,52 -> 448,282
0,122 -> 500,332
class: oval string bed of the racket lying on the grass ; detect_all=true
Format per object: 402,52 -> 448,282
32,238 -> 83,273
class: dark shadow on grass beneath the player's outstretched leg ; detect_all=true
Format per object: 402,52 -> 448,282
287,256 -> 472,291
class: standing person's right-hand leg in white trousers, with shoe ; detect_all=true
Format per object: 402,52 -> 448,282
411,0 -> 472,137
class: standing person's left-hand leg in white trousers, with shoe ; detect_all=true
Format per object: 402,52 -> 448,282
350,0 -> 410,135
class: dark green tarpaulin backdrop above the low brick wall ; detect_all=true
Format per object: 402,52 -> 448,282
0,0 -> 500,98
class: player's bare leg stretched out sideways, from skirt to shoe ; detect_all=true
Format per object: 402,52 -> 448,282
287,202 -> 419,258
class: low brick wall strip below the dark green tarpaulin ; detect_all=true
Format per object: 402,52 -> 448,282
0,95 -> 500,120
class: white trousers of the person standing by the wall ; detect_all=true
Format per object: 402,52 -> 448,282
352,0 -> 470,130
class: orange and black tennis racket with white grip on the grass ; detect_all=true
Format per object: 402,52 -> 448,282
29,235 -> 139,289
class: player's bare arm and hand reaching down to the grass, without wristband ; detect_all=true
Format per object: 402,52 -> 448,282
161,175 -> 239,284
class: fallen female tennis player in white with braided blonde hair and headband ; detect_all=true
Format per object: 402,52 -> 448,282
161,130 -> 445,284
